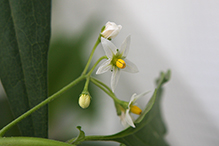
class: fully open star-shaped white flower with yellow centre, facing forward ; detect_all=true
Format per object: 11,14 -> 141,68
96,35 -> 138,92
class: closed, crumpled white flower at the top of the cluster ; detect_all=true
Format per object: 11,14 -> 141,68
101,22 -> 122,39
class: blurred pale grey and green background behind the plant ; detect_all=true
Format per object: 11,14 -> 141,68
0,0 -> 219,146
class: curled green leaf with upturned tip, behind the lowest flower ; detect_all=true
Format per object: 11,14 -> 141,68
81,71 -> 170,146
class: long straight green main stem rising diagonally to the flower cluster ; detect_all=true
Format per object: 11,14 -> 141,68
0,75 -> 86,137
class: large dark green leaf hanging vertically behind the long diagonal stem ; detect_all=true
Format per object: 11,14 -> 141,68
0,0 -> 51,137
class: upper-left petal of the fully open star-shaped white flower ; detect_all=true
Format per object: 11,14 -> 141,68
101,37 -> 116,59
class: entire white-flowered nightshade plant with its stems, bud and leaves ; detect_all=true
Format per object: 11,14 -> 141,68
0,0 -> 170,146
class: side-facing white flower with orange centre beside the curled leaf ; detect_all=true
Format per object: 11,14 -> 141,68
120,92 -> 148,128
